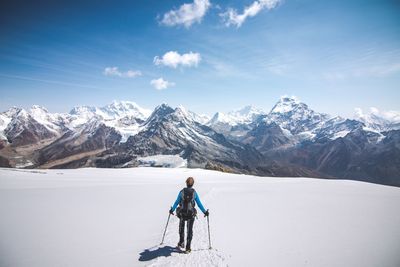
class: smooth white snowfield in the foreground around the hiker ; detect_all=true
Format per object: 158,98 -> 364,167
0,168 -> 400,267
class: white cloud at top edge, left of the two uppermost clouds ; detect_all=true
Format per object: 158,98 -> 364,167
161,0 -> 211,28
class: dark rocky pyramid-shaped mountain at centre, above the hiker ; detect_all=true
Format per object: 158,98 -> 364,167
123,104 -> 262,174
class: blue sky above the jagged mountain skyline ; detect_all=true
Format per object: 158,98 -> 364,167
0,0 -> 400,116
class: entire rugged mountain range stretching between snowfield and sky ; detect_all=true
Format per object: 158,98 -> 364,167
0,96 -> 400,186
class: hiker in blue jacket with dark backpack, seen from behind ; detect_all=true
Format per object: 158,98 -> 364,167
169,177 -> 209,253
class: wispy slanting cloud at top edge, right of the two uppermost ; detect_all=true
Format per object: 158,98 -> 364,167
220,0 -> 281,28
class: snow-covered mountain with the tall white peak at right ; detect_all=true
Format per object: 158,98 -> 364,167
207,96 -> 367,147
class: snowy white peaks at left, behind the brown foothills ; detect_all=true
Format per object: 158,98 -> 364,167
0,101 -> 151,146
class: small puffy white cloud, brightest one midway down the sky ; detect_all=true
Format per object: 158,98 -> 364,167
153,51 -> 201,68
